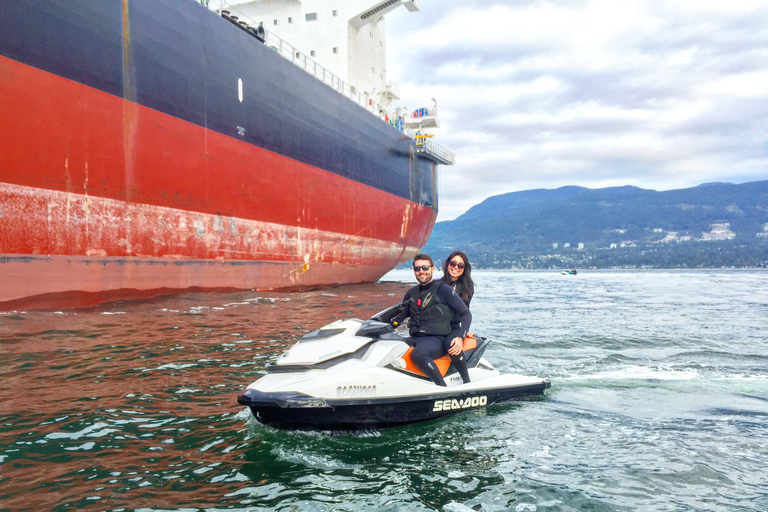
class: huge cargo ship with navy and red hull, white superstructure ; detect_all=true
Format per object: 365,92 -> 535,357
0,0 -> 454,310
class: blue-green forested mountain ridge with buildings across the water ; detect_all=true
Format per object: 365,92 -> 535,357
424,180 -> 768,268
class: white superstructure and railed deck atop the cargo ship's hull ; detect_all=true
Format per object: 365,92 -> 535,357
207,0 -> 455,165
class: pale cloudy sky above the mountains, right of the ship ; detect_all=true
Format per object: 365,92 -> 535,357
387,0 -> 768,220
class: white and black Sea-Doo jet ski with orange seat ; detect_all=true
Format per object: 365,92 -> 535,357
237,304 -> 550,431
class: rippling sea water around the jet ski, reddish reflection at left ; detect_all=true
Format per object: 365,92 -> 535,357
0,270 -> 768,512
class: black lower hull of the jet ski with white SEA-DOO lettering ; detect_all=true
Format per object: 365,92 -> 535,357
238,379 -> 550,431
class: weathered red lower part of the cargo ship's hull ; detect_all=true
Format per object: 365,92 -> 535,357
0,0 -> 437,309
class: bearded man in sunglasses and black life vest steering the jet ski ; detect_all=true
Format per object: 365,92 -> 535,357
392,254 -> 472,386
